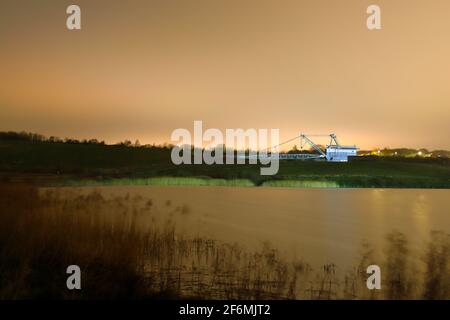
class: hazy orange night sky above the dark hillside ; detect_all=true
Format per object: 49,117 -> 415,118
0,0 -> 450,149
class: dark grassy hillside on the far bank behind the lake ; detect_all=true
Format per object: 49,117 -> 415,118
0,140 -> 450,188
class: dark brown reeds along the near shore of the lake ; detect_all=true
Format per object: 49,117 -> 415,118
0,184 -> 450,299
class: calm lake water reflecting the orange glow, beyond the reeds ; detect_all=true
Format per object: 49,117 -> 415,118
53,186 -> 450,268
